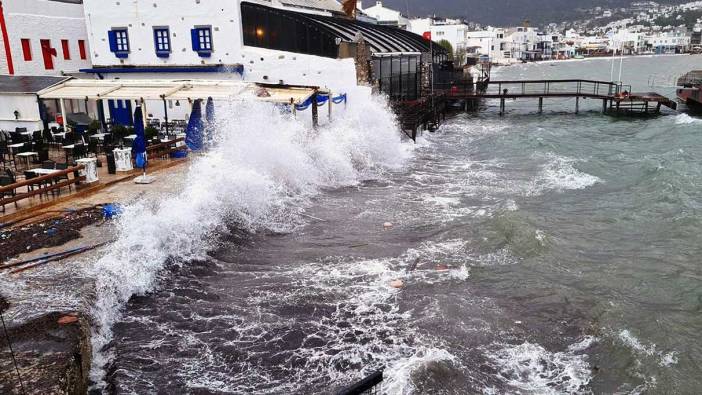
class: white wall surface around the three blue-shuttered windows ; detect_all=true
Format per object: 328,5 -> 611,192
85,0 -> 356,91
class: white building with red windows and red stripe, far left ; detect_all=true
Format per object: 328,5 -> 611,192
0,0 -> 90,75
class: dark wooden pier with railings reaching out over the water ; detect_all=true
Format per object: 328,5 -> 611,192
393,79 -> 677,139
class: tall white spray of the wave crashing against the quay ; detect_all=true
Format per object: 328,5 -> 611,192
91,88 -> 411,387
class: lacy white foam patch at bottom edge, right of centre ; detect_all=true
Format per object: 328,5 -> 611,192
486,337 -> 596,394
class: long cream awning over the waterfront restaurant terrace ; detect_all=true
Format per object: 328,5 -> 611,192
38,79 -> 317,104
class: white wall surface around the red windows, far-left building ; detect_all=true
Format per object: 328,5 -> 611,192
0,0 -> 90,75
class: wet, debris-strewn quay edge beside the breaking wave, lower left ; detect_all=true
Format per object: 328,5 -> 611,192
0,161 -> 189,394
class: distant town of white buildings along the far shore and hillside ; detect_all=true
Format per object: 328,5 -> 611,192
360,1 -> 702,65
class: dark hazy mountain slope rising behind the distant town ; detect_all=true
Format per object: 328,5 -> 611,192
380,0 -> 690,26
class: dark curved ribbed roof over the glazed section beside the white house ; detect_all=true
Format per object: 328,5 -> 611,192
242,2 -> 446,54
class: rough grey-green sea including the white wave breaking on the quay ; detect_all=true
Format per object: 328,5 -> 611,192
93,56 -> 702,394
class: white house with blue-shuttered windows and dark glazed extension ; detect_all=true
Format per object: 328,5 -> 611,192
83,0 -> 438,123
